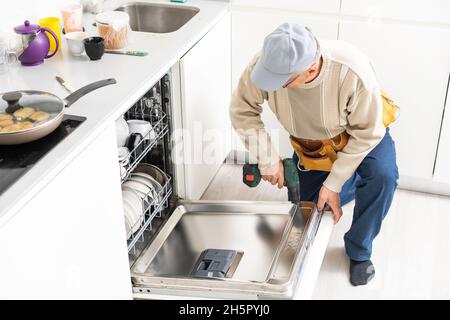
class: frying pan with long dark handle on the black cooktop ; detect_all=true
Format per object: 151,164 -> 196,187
0,79 -> 116,145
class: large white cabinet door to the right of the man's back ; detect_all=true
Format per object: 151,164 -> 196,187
339,20 -> 450,179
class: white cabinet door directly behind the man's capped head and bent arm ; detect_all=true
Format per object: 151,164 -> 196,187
232,8 -> 338,161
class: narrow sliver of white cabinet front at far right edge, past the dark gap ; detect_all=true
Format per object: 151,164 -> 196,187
433,73 -> 450,183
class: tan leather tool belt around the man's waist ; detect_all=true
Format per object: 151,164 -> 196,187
289,90 -> 400,171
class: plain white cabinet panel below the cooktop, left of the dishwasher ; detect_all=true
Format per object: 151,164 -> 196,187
0,125 -> 132,299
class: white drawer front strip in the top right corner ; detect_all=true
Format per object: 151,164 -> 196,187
341,0 -> 450,24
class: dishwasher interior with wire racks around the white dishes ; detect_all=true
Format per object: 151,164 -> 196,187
119,74 -> 176,266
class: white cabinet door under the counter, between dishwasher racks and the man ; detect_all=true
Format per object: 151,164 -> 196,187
180,14 -> 231,200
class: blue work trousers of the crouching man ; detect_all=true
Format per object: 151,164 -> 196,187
293,128 -> 398,261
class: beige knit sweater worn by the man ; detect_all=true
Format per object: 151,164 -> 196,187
230,40 -> 385,192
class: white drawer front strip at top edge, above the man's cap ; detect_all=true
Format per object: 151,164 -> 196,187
231,0 -> 340,13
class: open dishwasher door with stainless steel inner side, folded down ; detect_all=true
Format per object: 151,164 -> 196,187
131,201 -> 333,299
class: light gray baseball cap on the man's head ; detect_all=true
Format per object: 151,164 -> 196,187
251,23 -> 317,91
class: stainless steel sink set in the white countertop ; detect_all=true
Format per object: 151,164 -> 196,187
116,2 -> 200,33
